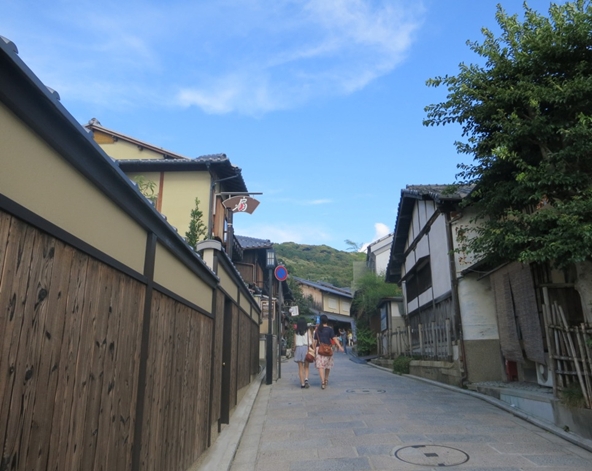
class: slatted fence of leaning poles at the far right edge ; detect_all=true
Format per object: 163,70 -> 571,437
543,288 -> 592,409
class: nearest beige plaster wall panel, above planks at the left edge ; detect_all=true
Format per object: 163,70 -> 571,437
0,104 -> 146,273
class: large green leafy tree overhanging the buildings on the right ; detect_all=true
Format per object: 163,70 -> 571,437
424,0 -> 592,316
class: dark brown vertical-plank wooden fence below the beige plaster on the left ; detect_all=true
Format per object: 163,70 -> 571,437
0,210 -> 259,471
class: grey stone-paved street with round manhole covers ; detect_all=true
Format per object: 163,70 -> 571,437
230,354 -> 592,471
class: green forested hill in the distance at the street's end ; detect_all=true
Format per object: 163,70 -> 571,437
273,242 -> 366,288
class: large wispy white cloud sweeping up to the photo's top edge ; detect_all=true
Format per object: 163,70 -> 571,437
177,0 -> 422,115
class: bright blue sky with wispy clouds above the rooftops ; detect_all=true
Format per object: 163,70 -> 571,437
0,0 -> 563,250
